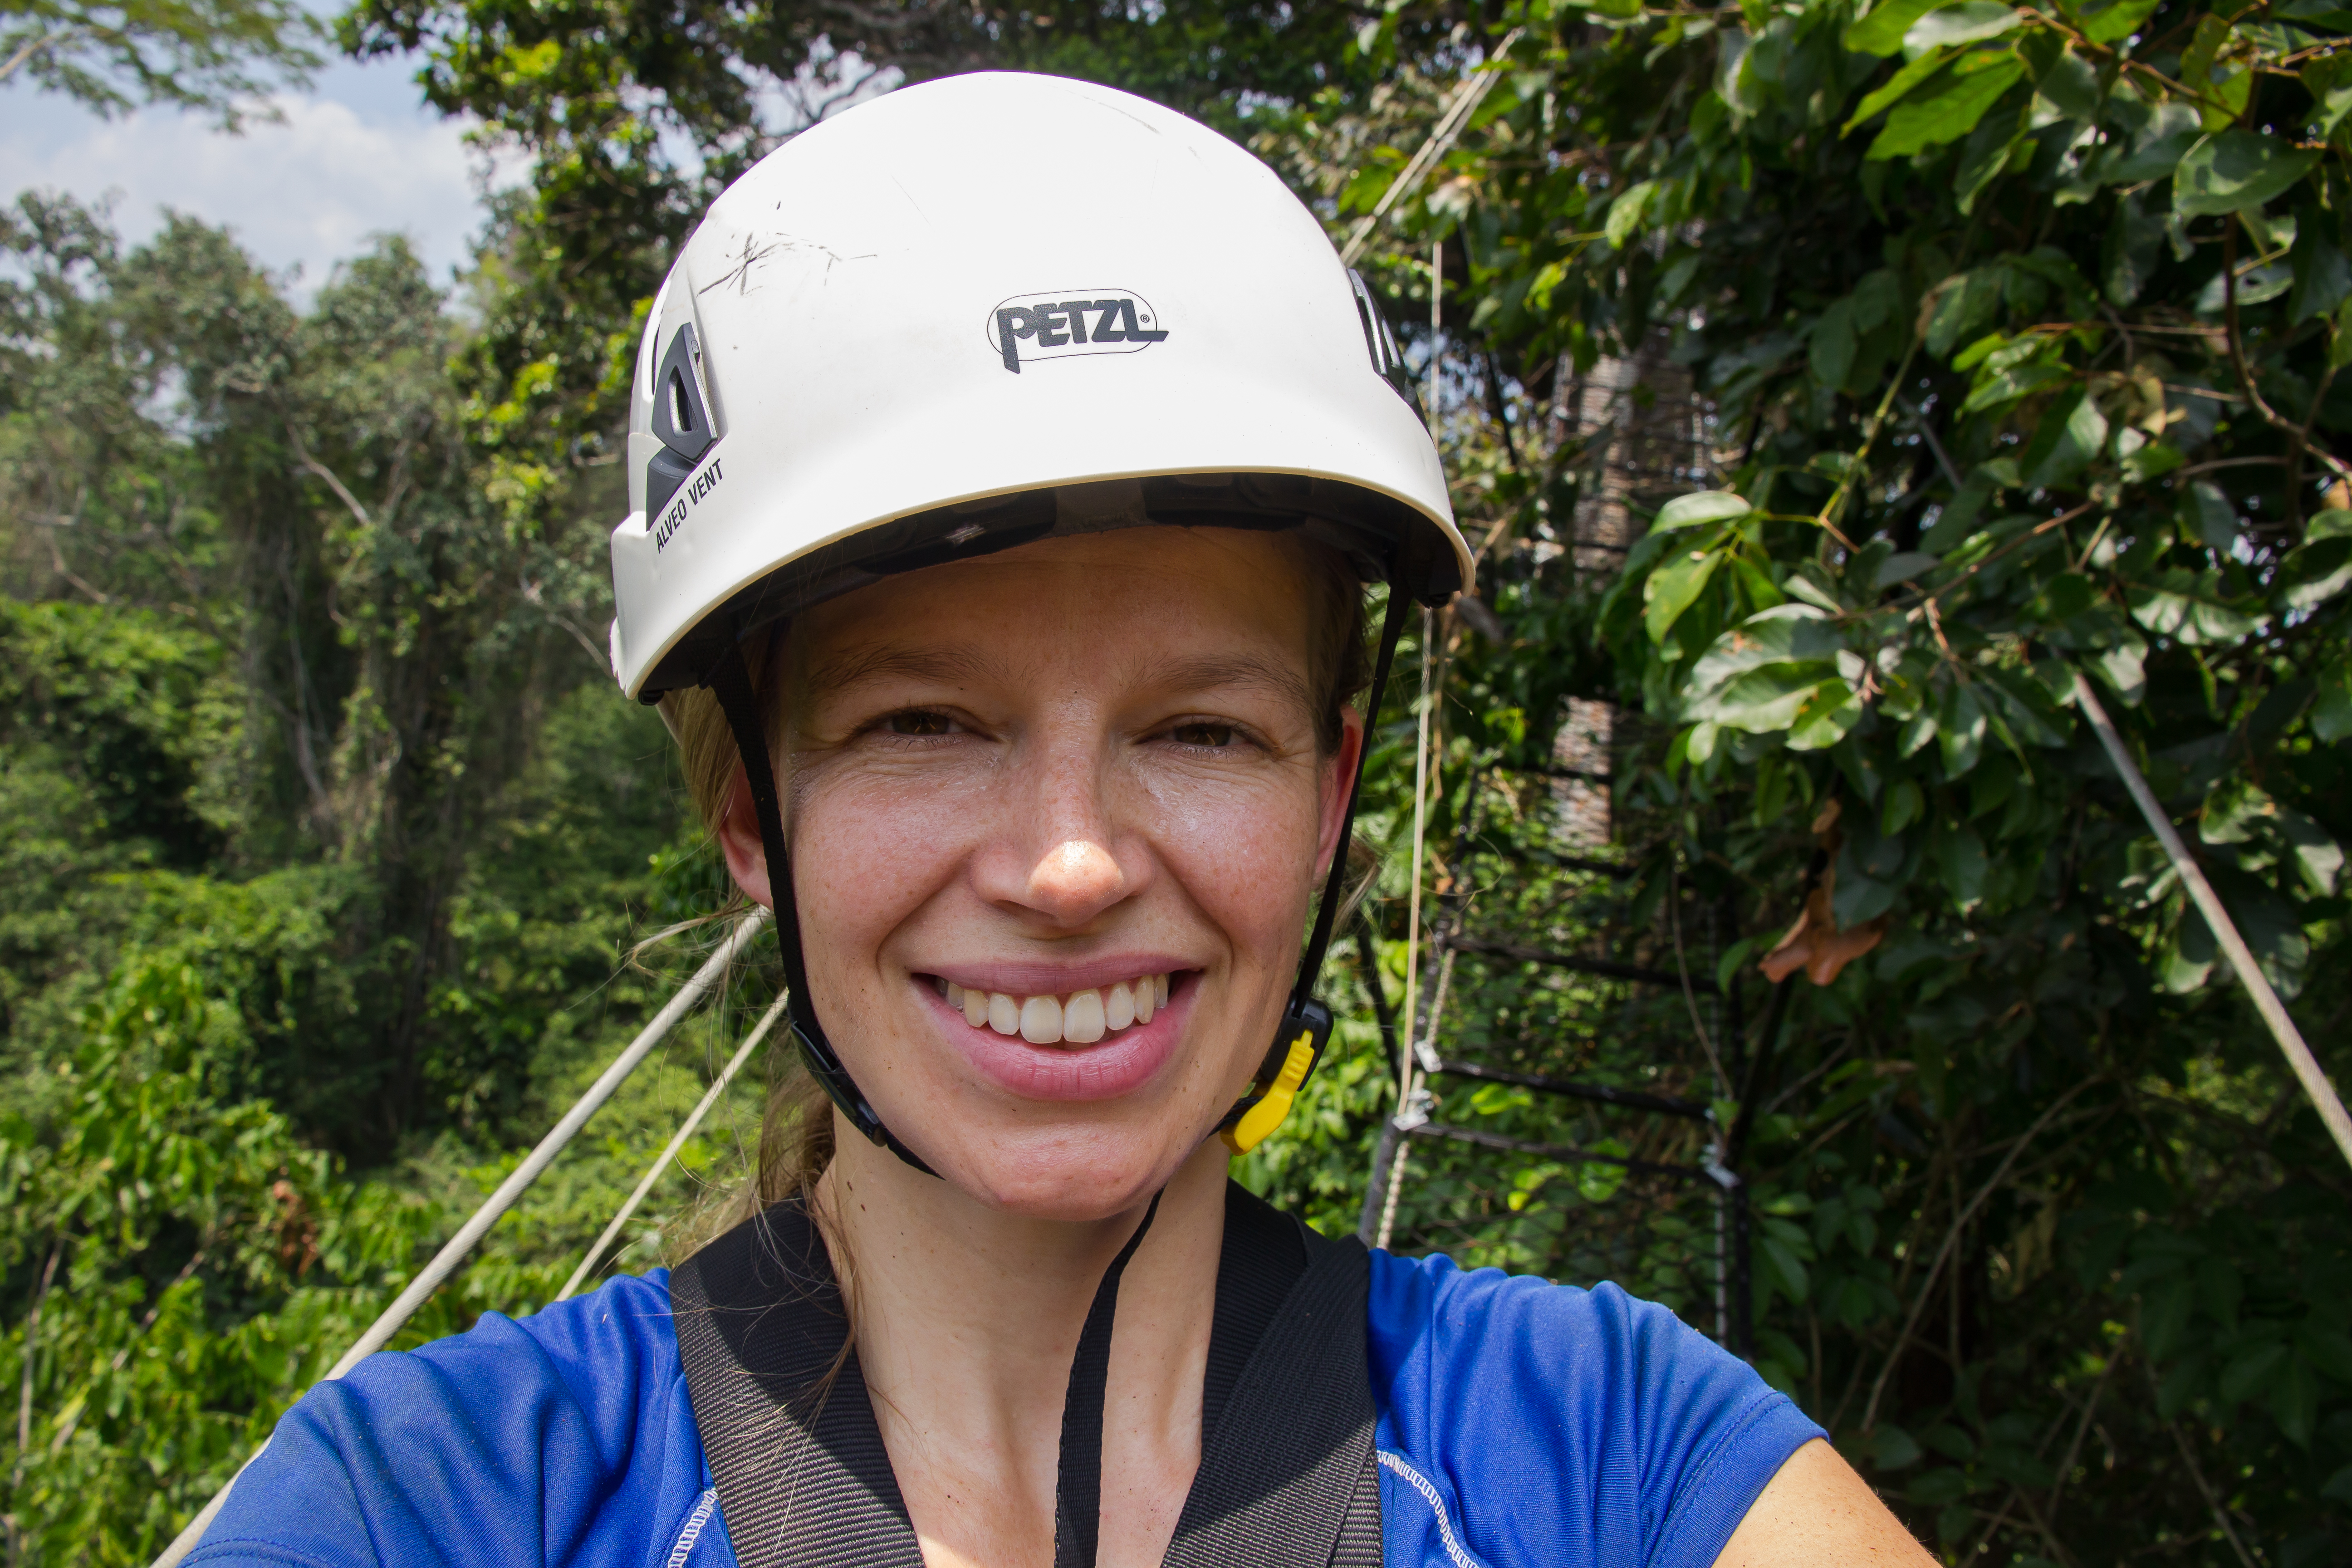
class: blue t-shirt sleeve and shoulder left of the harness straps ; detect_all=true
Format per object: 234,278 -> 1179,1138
188,1274 -> 703,1568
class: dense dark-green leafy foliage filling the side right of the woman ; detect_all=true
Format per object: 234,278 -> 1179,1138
1256,0 -> 2352,1561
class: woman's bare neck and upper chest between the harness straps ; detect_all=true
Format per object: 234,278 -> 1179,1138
816,1133 -> 1225,1568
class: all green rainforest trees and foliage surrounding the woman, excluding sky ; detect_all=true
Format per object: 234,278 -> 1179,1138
0,0 -> 2352,1568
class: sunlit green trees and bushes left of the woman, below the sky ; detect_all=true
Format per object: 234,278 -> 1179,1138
0,200 -> 769,1563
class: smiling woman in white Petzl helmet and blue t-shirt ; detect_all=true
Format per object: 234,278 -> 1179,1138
191,75 -> 1926,1568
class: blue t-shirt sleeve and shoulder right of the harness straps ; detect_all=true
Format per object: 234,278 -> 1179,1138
1371,1253 -> 1820,1568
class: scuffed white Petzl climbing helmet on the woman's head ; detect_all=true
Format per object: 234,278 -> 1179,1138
597,73 -> 1470,701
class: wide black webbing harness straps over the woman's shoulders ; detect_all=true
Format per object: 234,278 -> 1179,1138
670,1185 -> 1381,1568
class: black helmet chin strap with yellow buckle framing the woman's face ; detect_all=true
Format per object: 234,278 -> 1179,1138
710,585 -> 1414,1171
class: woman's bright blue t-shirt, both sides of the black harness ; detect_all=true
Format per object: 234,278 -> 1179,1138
188,1253 -> 1820,1568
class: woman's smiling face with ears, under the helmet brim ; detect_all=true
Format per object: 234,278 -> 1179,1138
722,529 -> 1362,1220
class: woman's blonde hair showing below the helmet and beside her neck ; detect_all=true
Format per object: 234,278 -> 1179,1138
661,534 -> 1371,1222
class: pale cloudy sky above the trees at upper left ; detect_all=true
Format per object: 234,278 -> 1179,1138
0,44 -> 510,299
